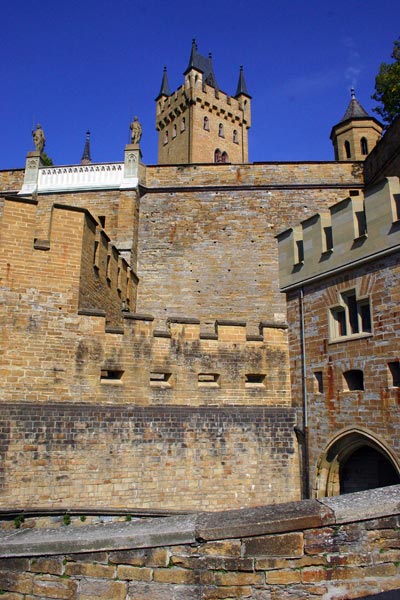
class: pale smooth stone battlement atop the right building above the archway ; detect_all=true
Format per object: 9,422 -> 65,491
277,177 -> 400,290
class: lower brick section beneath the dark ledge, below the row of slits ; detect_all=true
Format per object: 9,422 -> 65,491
0,403 -> 299,510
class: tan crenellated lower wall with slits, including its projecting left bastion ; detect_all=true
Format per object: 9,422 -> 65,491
0,198 -> 299,510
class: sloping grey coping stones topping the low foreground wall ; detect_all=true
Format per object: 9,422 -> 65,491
0,485 -> 400,558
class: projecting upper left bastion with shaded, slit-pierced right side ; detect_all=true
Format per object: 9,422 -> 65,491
1,196 -> 138,324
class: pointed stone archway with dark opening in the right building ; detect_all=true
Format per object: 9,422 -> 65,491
314,429 -> 400,498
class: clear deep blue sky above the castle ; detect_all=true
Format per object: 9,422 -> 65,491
0,0 -> 400,169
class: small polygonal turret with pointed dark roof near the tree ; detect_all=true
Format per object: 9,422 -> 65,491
330,88 -> 383,160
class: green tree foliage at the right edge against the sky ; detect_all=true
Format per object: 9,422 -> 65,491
372,38 -> 400,125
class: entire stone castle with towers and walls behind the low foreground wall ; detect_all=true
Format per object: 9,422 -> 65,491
0,42 -> 400,512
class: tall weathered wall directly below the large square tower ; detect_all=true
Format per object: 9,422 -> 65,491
138,163 -> 362,324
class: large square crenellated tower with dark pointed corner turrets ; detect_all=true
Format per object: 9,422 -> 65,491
156,40 -> 251,164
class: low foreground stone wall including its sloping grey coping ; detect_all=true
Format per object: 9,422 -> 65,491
0,486 -> 400,600
